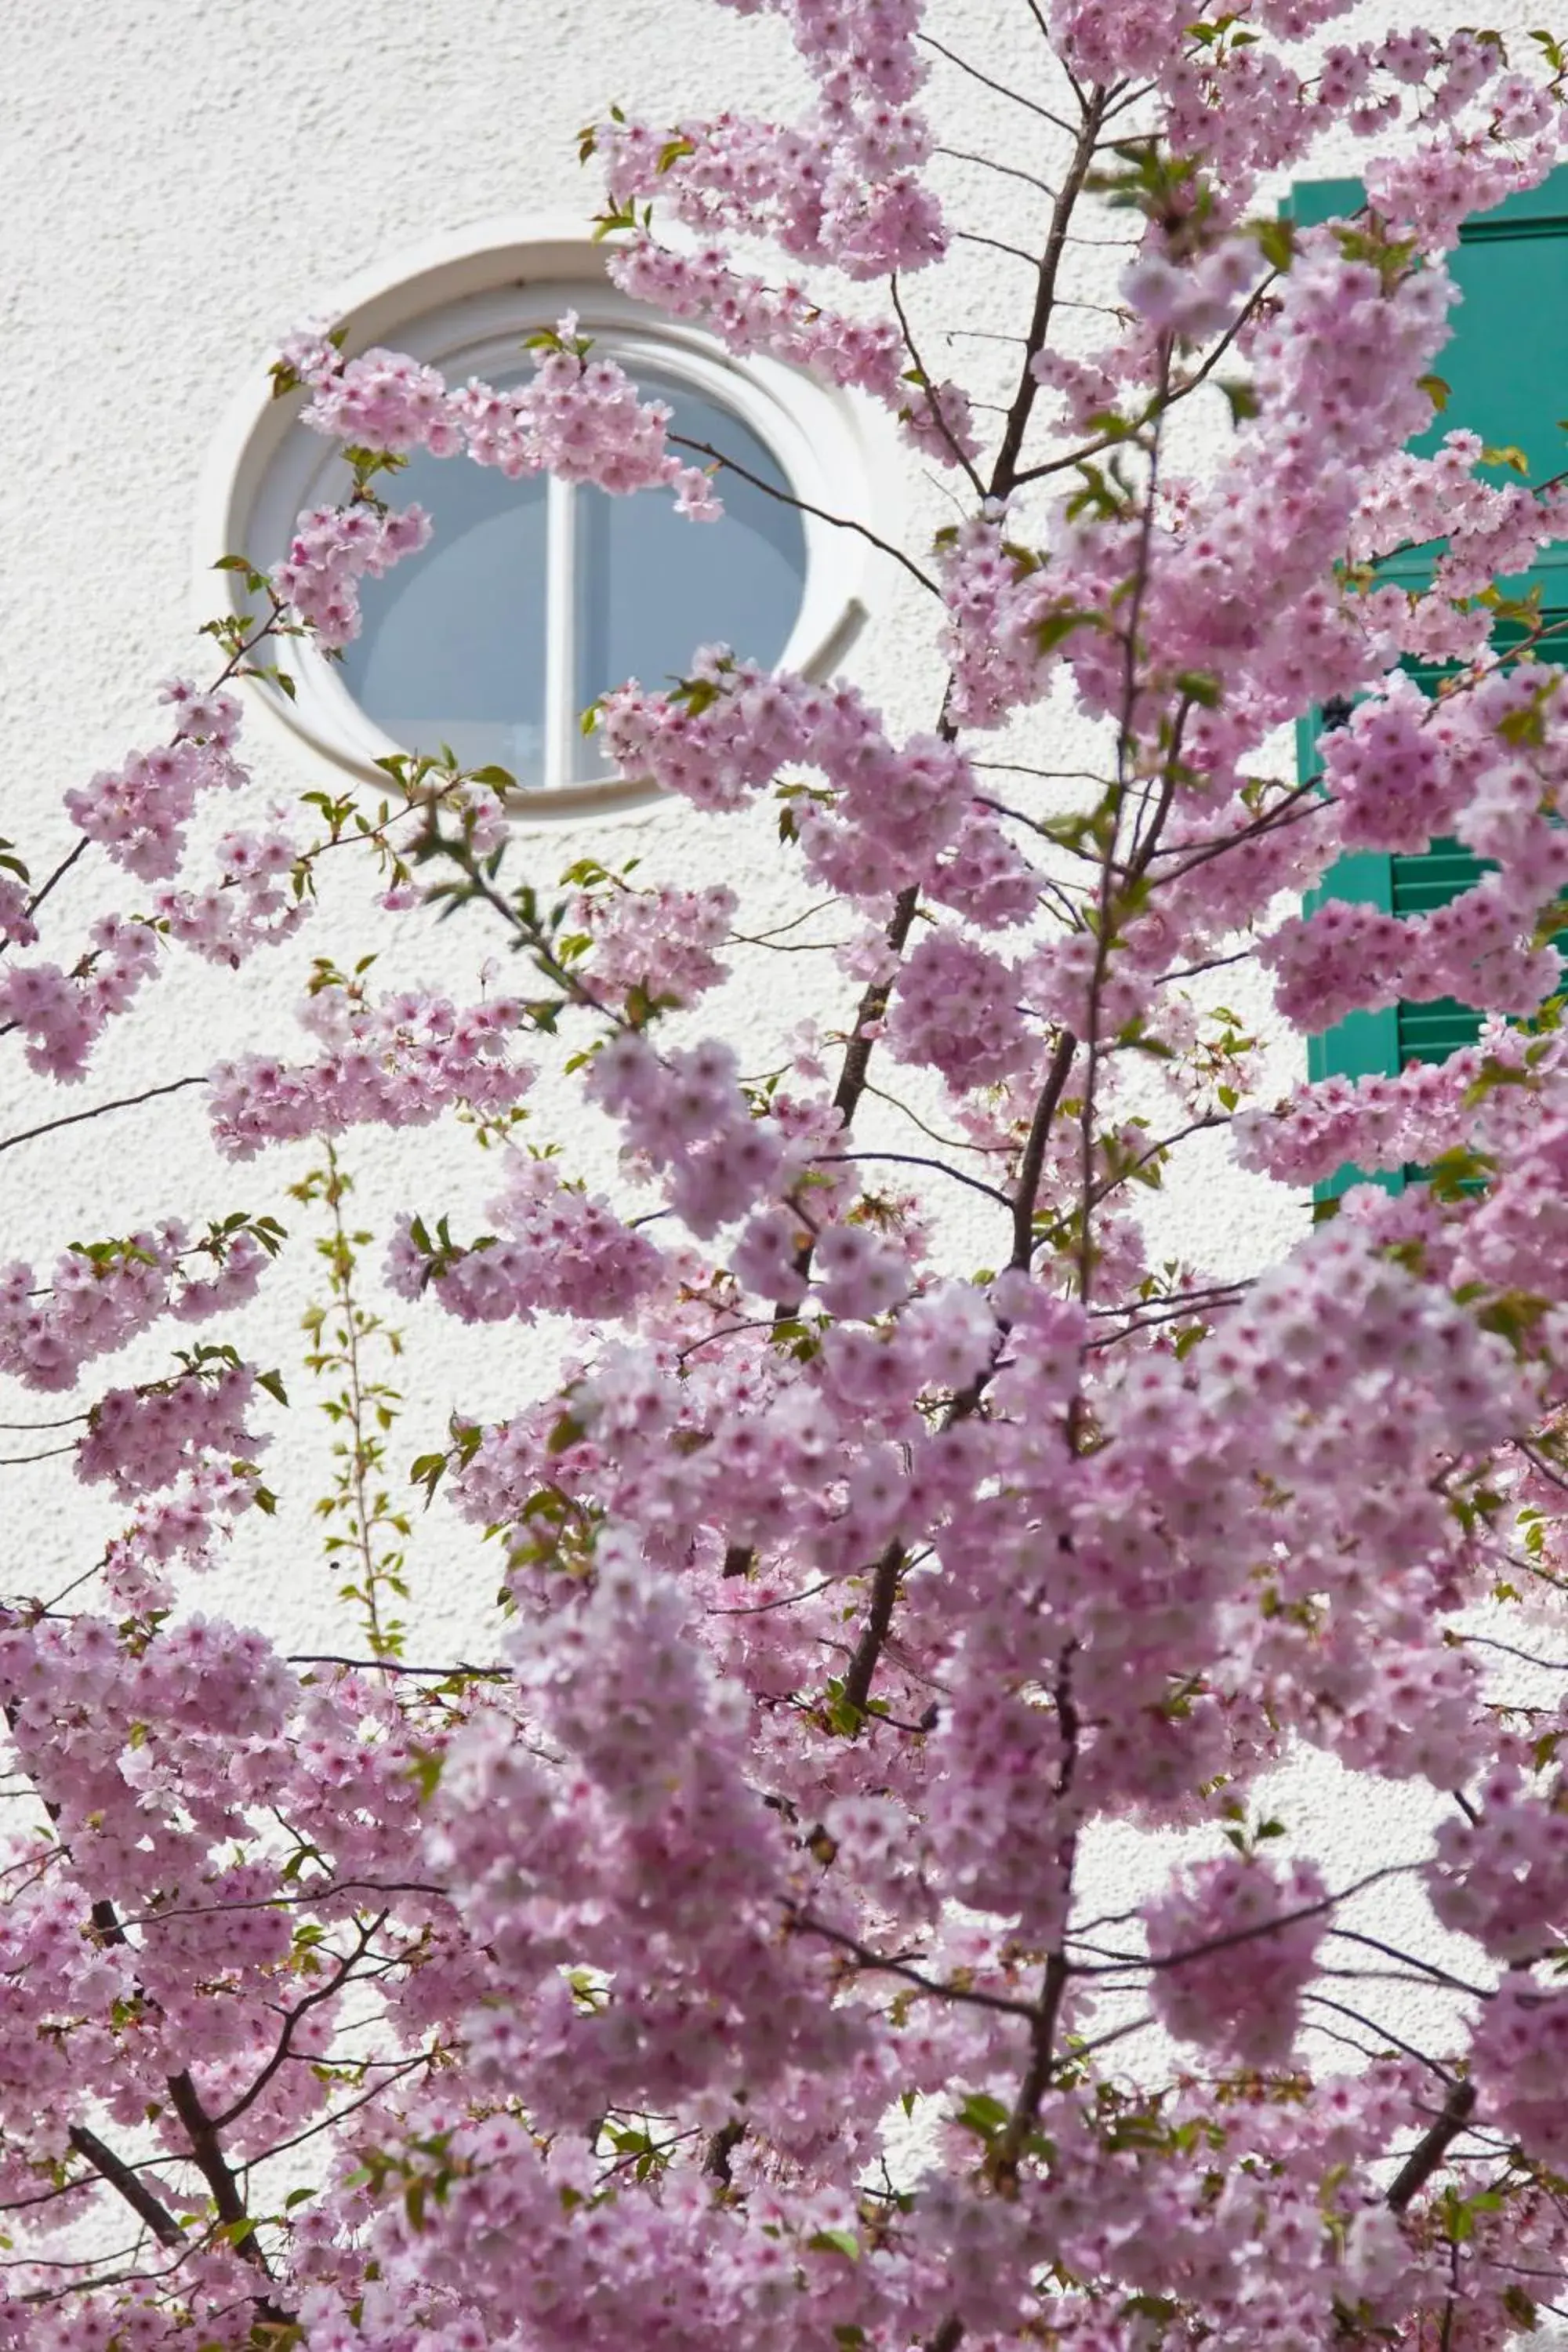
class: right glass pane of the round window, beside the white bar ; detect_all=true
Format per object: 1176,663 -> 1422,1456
574,369 -> 806,724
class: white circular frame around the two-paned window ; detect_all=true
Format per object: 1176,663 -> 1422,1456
198,219 -> 891,823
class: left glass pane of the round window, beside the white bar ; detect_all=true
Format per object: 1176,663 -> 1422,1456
343,433 -> 546,783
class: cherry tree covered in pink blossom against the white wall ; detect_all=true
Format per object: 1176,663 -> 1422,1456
0,0 -> 1568,2352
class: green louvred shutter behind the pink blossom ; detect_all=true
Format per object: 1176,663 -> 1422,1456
1288,167 -> 1568,1197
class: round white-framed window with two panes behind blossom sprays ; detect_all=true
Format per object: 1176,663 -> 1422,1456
202,224 -> 865,814
